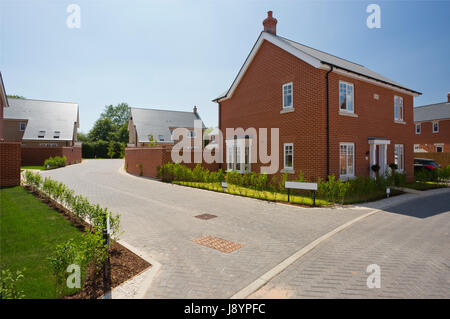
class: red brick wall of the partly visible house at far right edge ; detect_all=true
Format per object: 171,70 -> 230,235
414,120 -> 450,153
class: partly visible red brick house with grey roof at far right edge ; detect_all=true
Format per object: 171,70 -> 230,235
414,93 -> 450,153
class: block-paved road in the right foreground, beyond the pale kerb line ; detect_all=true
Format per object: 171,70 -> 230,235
251,193 -> 450,298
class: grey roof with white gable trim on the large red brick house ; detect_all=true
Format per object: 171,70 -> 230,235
213,31 -> 421,101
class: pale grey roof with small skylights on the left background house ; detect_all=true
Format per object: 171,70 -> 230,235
4,98 -> 79,141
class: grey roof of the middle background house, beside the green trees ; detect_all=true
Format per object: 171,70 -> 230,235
130,107 -> 205,143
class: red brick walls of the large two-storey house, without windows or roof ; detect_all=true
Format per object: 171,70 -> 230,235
219,41 -> 414,180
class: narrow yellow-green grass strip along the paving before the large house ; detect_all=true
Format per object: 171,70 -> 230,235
173,182 -> 330,206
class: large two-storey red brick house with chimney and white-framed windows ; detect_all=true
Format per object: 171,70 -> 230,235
214,11 -> 421,180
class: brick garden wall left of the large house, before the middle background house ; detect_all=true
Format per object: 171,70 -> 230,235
125,146 -> 219,178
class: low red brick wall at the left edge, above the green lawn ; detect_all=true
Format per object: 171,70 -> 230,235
0,142 -> 21,187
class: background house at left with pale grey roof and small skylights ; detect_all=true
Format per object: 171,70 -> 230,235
3,98 -> 81,165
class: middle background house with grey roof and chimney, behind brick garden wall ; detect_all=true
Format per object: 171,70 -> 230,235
128,106 -> 205,147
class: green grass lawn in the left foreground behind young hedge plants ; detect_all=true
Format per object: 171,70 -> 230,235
0,186 -> 82,298
